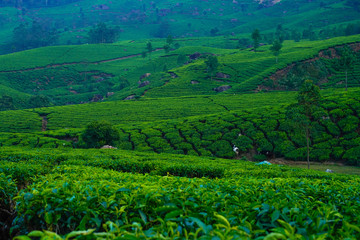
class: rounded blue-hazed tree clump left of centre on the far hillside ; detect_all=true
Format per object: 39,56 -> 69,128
88,23 -> 119,43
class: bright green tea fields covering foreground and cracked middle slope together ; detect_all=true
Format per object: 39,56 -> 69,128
0,88 -> 360,239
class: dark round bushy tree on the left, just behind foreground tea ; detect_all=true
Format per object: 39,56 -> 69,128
81,120 -> 120,148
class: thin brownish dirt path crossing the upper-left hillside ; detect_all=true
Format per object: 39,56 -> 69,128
0,48 -> 163,73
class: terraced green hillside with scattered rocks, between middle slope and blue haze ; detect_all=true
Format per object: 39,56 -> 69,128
0,35 -> 359,108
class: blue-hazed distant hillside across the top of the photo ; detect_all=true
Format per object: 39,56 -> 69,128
0,0 -> 360,53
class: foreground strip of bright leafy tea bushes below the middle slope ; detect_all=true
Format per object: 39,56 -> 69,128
0,148 -> 360,239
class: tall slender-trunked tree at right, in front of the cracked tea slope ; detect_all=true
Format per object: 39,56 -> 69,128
286,80 -> 323,169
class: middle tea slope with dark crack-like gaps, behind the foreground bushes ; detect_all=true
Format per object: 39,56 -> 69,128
0,88 -> 360,165
